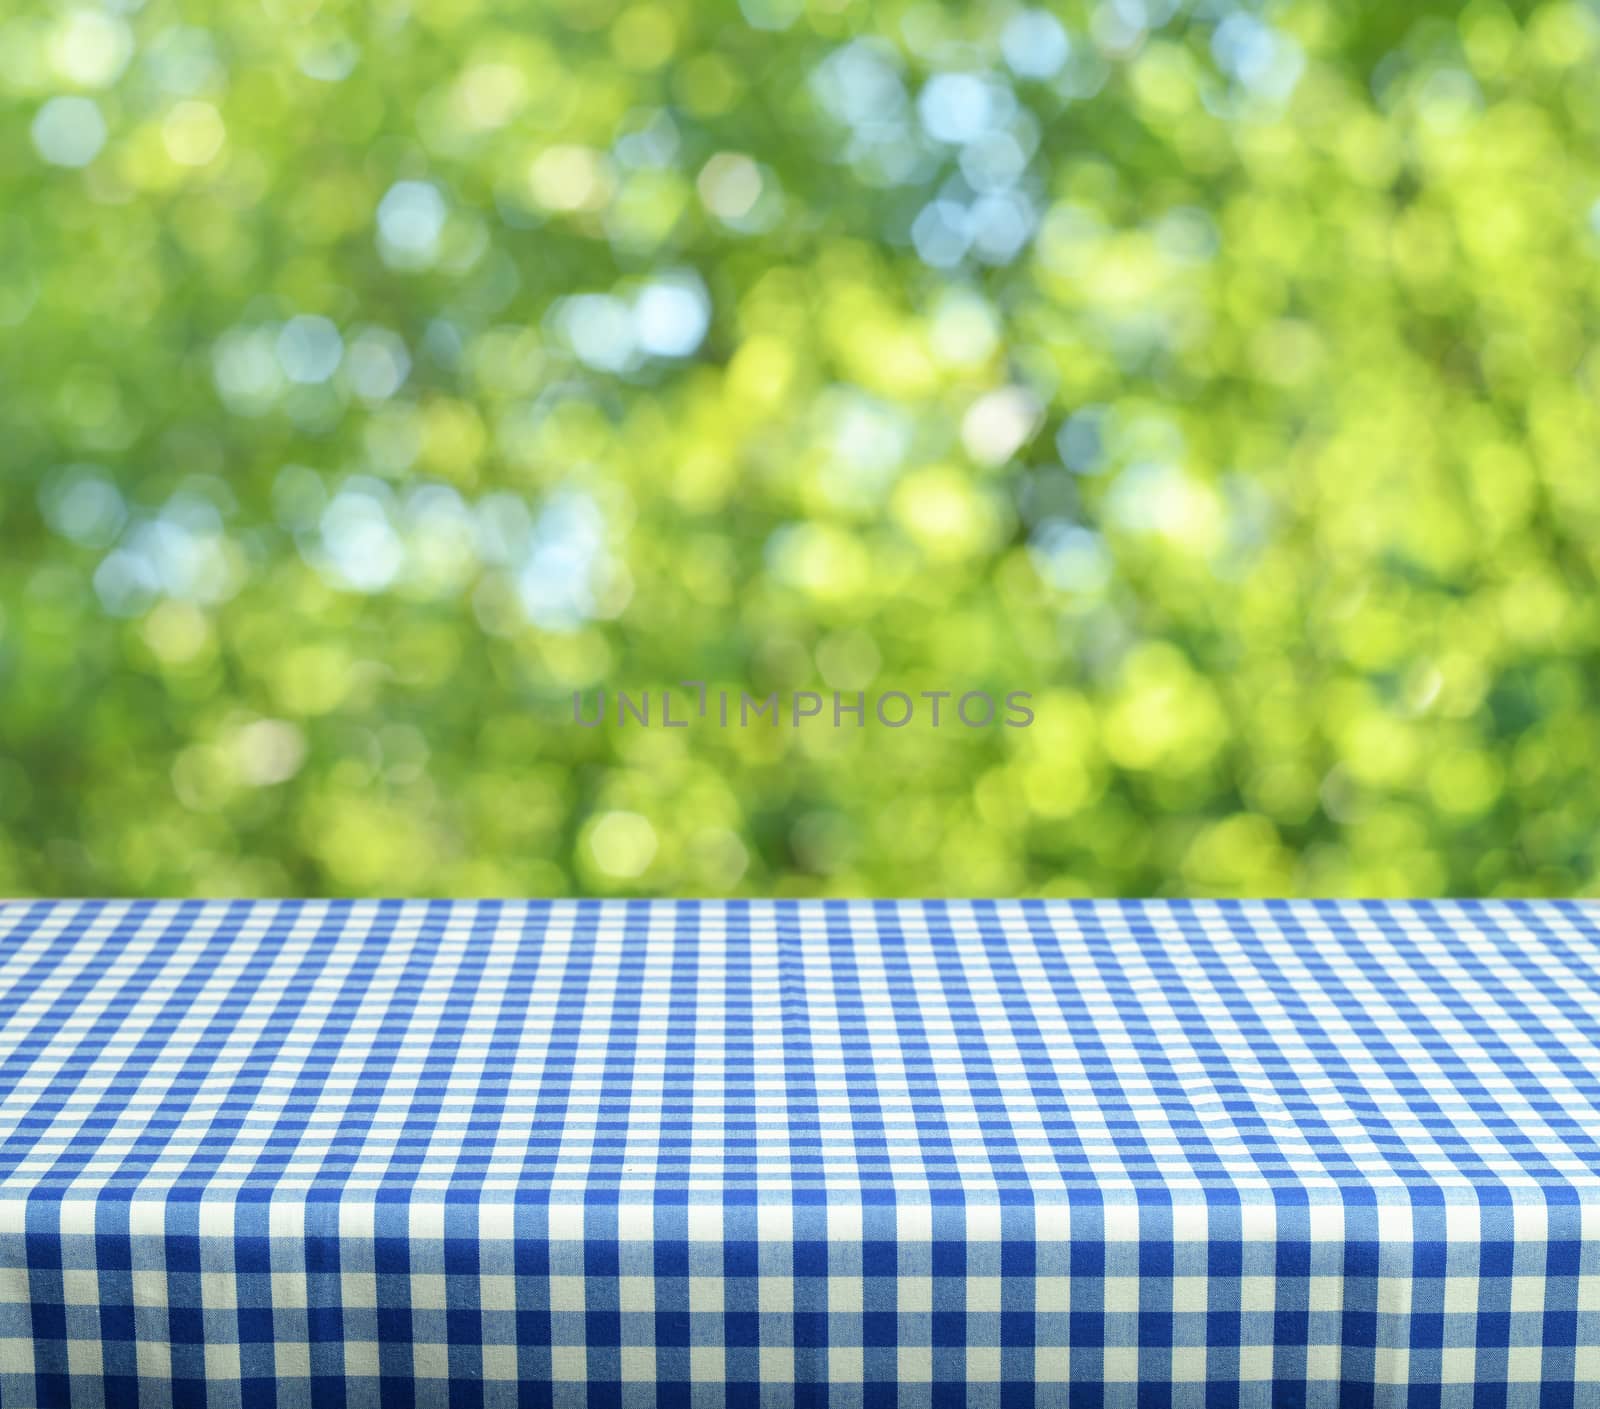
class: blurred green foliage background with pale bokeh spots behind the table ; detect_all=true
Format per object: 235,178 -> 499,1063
0,0 -> 1600,896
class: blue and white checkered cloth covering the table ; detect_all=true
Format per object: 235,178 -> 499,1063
0,902 -> 1600,1409
